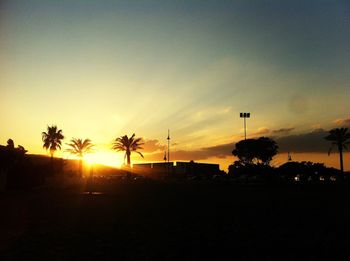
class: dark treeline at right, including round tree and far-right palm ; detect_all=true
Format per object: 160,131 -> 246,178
228,132 -> 350,183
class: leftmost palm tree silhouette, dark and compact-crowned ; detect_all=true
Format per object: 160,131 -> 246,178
41,125 -> 64,168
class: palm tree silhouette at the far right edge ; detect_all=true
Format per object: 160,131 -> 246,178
325,128 -> 350,173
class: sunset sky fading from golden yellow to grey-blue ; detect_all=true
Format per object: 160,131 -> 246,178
0,0 -> 350,170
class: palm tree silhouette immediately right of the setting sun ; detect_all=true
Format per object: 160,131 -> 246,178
112,133 -> 144,167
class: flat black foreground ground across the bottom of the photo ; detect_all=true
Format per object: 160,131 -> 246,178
0,181 -> 350,261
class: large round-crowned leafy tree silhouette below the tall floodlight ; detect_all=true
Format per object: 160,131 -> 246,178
232,137 -> 278,165
